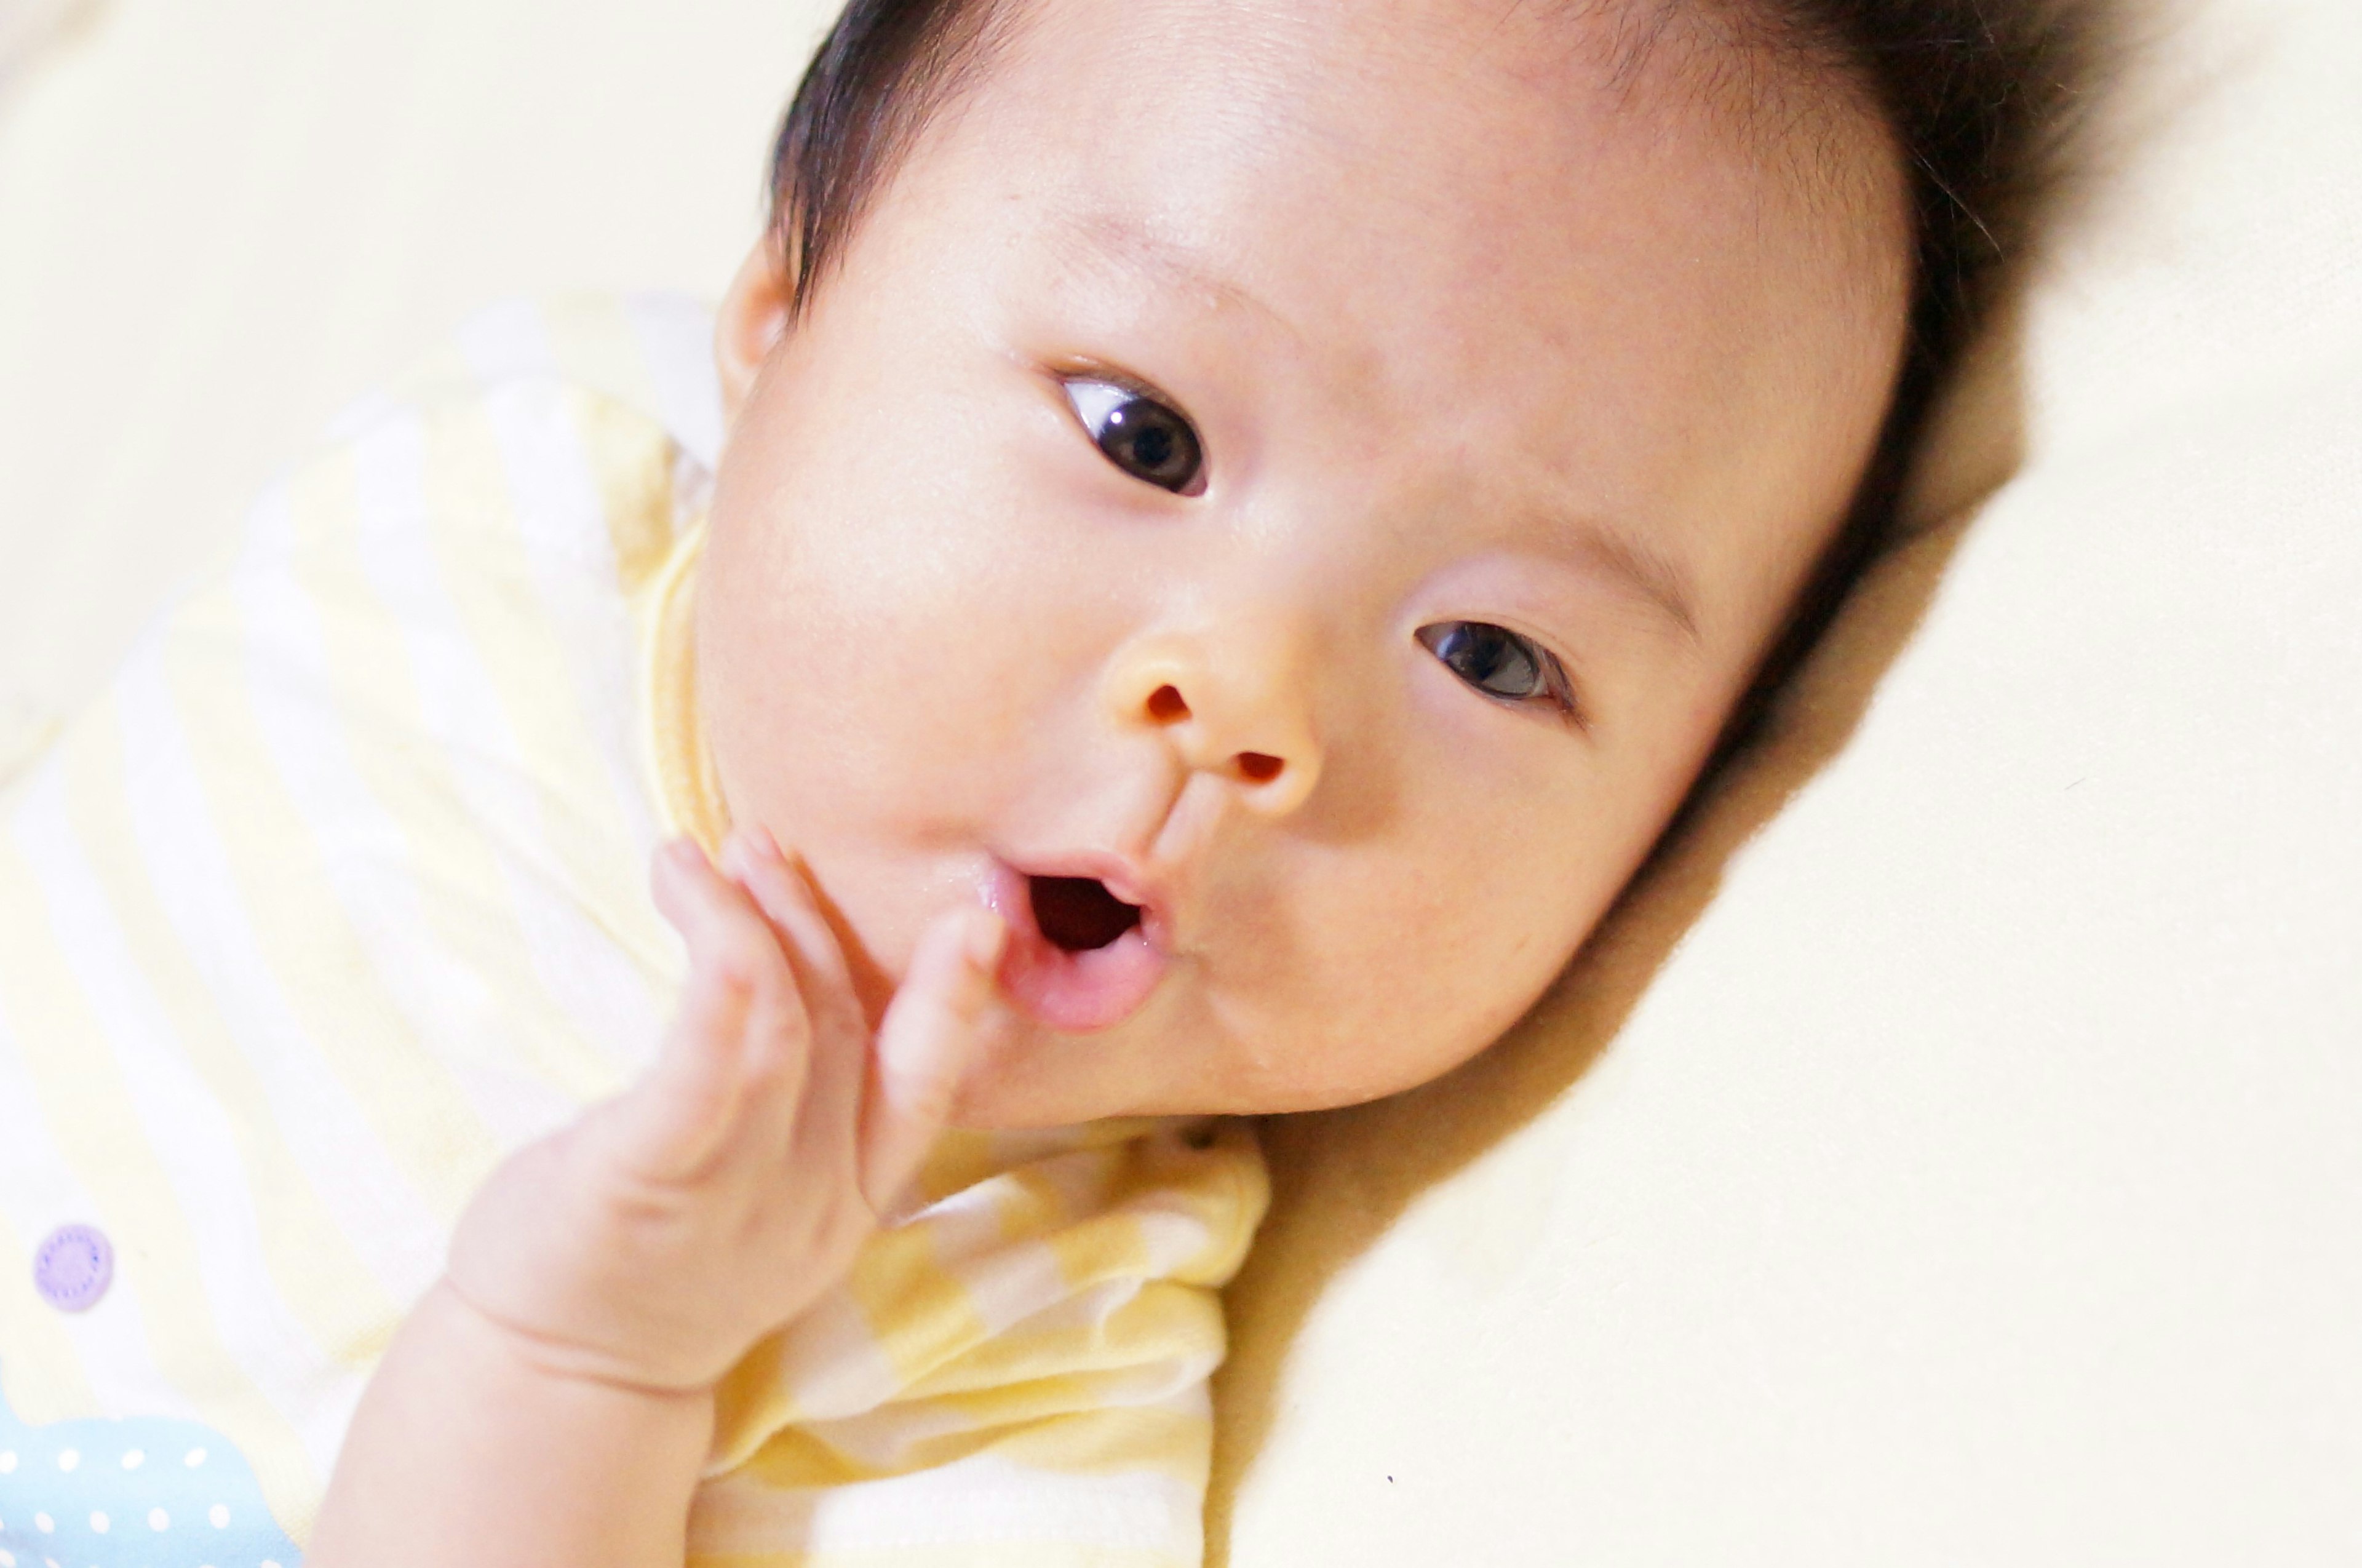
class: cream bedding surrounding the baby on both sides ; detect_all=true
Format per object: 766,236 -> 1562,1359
0,0 -> 2362,1568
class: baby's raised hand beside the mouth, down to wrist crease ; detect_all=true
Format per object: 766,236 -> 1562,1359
449,834 -> 1006,1391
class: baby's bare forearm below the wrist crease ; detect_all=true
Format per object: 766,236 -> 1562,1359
304,1284 -> 714,1568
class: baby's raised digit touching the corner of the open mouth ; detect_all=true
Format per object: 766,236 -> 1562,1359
860,909 -> 1009,1219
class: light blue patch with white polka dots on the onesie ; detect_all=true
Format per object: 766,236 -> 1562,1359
0,1400 -> 298,1568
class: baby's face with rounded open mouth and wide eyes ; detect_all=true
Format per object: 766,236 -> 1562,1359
697,0 -> 1909,1126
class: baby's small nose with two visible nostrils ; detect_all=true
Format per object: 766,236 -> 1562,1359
1108,628 -> 1321,817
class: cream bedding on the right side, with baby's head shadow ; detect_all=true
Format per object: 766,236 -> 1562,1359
1214,0 -> 2362,1568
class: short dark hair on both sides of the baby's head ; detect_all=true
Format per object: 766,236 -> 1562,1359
770,0 -> 2107,755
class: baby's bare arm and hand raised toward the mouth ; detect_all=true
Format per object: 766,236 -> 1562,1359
304,836 -> 1004,1568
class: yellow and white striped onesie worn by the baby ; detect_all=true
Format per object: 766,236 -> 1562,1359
0,298 -> 1263,1568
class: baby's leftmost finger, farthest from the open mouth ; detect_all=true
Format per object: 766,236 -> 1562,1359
610,843 -> 808,1180
